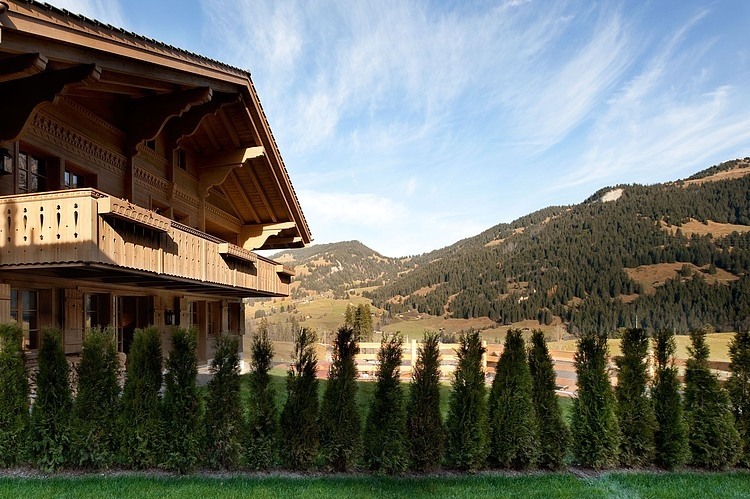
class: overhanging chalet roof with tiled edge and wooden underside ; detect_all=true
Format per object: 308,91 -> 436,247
0,0 -> 311,249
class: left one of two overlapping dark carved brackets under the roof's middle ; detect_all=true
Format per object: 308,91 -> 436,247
123,87 -> 212,156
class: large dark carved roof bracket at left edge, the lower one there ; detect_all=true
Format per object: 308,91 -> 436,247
0,64 -> 101,140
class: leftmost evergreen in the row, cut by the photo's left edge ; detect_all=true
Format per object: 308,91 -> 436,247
0,323 -> 29,468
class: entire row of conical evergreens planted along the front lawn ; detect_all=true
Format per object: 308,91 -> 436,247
0,324 -> 750,473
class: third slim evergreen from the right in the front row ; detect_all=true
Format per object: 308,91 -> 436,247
651,330 -> 690,469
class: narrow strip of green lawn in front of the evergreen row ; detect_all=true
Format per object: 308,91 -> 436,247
0,472 -> 750,499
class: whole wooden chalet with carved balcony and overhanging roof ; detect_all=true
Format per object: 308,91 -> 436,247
0,0 -> 311,360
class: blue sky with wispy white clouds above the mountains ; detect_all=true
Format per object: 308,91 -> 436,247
50,0 -> 750,256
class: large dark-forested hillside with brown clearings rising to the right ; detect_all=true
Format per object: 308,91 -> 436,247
366,158 -> 750,332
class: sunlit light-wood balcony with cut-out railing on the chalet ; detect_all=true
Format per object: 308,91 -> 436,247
0,189 -> 294,297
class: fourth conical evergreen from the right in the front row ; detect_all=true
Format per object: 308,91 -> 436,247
615,328 -> 656,466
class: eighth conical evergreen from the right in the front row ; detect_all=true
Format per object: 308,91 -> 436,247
446,330 -> 489,471
